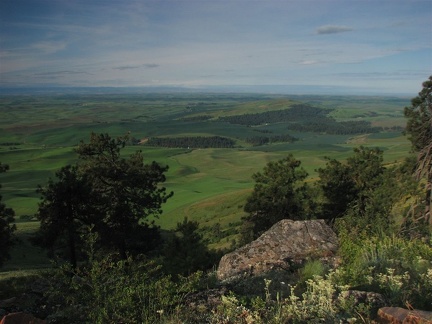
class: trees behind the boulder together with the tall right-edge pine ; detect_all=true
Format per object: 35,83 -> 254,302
241,77 -> 432,240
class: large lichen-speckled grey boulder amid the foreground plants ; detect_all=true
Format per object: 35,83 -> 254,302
217,219 -> 338,281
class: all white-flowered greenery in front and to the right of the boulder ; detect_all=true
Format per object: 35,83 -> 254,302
208,232 -> 432,323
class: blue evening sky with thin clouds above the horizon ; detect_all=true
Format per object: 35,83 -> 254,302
0,0 -> 432,94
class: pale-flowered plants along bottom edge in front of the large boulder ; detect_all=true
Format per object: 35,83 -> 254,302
208,271 -> 371,324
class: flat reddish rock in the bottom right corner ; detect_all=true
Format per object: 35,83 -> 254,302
378,307 -> 432,324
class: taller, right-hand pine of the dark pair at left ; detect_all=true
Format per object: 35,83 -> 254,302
76,133 -> 173,258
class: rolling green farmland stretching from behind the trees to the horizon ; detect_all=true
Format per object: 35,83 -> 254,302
0,93 -> 410,251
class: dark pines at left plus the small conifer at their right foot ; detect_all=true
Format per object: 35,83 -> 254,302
27,134 -> 220,275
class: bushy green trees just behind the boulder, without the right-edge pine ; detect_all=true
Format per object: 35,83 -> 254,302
241,142 -> 427,244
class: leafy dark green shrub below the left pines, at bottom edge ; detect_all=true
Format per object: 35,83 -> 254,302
46,232 -> 202,323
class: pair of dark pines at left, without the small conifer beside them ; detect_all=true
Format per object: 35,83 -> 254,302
36,133 -> 173,265
